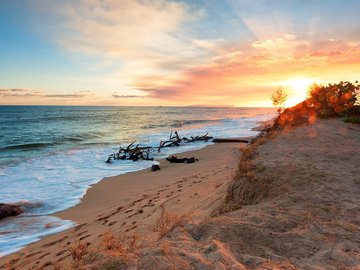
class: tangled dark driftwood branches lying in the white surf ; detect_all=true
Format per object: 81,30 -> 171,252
106,131 -> 213,163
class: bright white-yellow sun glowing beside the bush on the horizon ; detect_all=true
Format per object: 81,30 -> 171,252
281,78 -> 314,107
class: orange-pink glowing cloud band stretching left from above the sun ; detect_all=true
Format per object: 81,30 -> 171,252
133,34 -> 360,104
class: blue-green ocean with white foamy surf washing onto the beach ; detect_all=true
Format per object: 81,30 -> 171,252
0,106 -> 275,257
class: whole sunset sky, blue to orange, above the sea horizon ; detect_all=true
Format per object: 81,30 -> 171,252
0,0 -> 360,107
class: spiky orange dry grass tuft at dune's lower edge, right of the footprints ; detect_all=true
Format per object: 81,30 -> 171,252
153,205 -> 190,239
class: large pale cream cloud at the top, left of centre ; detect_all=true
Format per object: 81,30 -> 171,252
32,0 -> 203,72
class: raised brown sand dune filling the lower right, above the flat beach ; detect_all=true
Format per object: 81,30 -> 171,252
135,120 -> 360,269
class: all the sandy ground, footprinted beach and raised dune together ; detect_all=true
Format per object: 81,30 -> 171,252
0,119 -> 360,270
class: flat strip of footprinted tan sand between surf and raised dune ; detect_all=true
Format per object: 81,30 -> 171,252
0,143 -> 246,269
